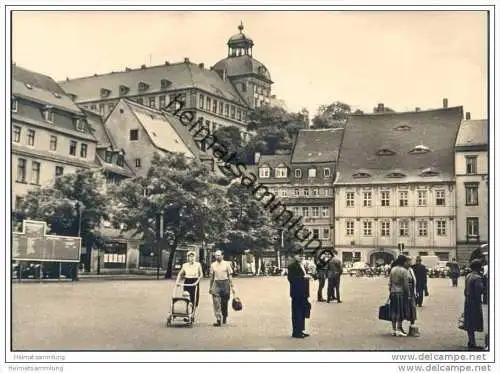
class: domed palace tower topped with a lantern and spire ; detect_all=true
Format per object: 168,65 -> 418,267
214,22 -> 273,109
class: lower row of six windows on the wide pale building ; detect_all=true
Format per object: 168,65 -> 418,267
345,219 -> 447,237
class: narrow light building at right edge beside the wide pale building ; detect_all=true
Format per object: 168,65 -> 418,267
455,113 -> 489,264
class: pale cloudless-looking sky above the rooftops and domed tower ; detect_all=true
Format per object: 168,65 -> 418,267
12,11 -> 488,119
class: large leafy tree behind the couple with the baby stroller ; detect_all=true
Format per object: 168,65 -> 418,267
114,153 -> 227,278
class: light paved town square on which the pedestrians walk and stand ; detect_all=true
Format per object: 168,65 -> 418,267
12,276 -> 487,350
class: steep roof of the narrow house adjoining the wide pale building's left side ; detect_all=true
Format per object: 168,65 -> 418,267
292,128 -> 343,163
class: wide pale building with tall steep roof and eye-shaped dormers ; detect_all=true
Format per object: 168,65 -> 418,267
334,107 -> 462,265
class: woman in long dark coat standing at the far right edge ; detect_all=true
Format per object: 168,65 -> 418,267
464,259 -> 483,350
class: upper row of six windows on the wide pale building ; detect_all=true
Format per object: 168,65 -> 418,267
345,190 -> 446,207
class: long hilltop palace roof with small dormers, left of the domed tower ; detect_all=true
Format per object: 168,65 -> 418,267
60,62 -> 247,106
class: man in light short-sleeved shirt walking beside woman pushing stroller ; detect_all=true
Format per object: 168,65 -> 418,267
209,250 -> 235,326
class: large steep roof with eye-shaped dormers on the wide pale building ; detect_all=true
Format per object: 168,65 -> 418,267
336,107 -> 463,184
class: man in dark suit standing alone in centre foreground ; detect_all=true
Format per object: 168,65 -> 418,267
288,248 -> 310,338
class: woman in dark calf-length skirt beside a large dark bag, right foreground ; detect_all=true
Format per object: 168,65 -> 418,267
389,254 -> 410,337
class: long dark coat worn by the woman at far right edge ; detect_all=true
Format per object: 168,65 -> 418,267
464,272 -> 483,332
